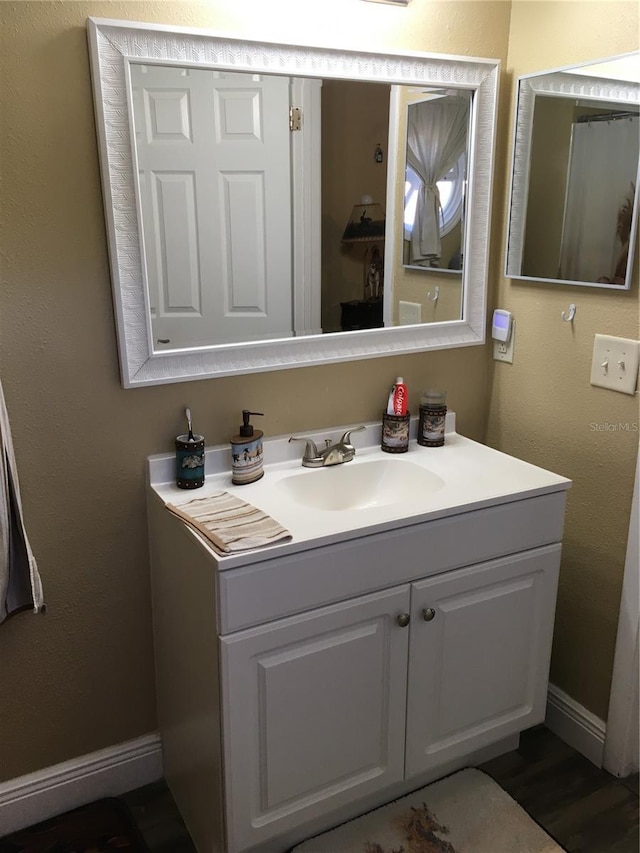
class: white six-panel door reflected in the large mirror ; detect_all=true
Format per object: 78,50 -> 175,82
131,64 -> 293,349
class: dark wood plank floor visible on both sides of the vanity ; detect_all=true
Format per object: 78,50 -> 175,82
122,726 -> 640,853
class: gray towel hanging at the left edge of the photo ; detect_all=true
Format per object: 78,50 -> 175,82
0,383 -> 44,623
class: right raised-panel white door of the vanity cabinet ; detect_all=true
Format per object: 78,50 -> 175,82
406,545 -> 560,778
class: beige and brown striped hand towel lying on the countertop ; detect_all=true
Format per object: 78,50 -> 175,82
166,492 -> 291,554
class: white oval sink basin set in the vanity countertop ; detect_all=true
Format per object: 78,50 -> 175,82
276,457 -> 444,512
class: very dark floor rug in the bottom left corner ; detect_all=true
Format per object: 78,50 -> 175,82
0,797 -> 149,853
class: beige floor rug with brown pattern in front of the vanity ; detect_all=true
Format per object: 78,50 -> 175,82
293,768 -> 563,853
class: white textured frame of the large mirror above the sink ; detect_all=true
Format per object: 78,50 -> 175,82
87,18 -> 500,388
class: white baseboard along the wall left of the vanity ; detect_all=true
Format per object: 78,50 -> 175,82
0,734 -> 162,836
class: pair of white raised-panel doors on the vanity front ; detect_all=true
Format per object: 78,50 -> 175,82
220,545 -> 560,851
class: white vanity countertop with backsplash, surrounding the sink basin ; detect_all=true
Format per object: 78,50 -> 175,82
148,413 -> 571,569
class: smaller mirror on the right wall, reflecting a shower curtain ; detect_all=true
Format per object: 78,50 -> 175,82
505,52 -> 640,290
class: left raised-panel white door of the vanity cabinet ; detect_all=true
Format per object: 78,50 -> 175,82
220,585 -> 410,853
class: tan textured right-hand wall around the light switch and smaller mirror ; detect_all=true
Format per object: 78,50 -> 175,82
488,0 -> 640,719
